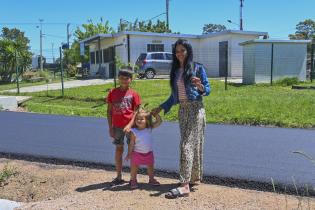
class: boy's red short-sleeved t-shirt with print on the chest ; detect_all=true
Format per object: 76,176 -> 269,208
107,88 -> 141,128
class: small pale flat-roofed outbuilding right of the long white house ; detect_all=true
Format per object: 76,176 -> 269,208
240,40 -> 311,84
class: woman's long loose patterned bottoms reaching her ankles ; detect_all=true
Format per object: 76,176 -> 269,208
178,101 -> 206,183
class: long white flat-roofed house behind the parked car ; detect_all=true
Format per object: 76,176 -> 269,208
80,30 -> 268,78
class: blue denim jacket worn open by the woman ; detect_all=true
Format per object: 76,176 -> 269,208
160,63 -> 211,114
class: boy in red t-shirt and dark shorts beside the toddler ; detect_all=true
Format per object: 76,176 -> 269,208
107,70 -> 141,185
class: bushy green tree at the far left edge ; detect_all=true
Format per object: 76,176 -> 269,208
0,27 -> 32,81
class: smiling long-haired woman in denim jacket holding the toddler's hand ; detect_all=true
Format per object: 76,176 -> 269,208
152,39 -> 210,198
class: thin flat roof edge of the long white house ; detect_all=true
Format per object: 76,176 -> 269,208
80,30 -> 268,44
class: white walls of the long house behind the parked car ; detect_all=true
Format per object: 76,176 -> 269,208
90,34 -> 268,77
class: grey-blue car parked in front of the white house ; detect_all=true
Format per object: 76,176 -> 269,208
135,52 -> 173,79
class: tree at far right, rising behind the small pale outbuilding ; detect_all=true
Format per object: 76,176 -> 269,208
289,19 -> 315,40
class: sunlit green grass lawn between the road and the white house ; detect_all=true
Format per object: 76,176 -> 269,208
6,80 -> 315,128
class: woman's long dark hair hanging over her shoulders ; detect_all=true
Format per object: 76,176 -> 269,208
170,39 -> 193,91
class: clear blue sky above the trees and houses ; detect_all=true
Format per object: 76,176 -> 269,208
0,0 -> 315,62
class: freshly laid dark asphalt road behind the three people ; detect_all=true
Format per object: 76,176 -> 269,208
0,112 -> 315,186
